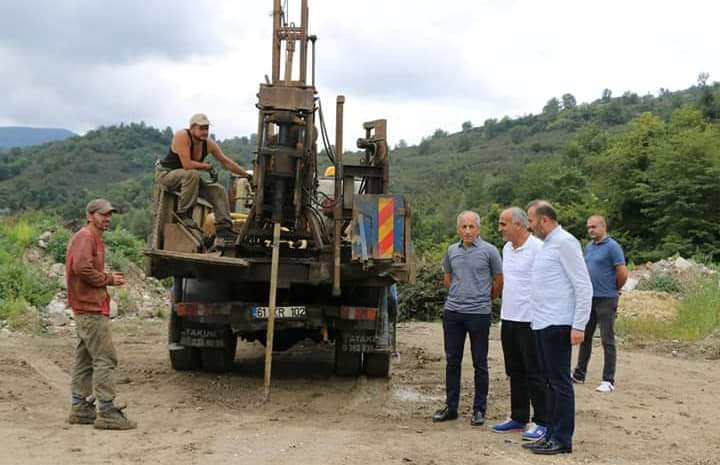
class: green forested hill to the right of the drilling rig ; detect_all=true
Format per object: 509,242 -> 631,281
391,80 -> 720,262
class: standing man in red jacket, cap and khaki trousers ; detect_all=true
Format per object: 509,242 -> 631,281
65,199 -> 137,430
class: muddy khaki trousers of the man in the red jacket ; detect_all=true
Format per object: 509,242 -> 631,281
71,313 -> 117,403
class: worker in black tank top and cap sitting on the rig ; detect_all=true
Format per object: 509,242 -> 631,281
155,113 -> 250,240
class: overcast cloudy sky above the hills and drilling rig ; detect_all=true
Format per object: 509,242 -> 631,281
0,0 -> 720,148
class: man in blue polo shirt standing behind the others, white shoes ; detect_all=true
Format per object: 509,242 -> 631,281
573,215 -> 628,392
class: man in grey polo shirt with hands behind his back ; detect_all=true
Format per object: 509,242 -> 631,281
432,211 -> 502,426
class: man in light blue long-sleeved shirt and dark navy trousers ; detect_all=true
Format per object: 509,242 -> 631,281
523,200 -> 592,455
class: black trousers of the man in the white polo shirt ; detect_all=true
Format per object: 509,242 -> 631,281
500,320 -> 548,426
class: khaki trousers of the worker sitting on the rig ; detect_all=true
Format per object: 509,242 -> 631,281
155,166 -> 232,226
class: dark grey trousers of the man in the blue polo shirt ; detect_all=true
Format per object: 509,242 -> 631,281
575,297 -> 618,384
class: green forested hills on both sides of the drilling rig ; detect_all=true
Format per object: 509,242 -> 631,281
0,80 -> 720,261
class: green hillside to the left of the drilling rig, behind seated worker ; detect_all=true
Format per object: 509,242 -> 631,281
0,123 -> 254,218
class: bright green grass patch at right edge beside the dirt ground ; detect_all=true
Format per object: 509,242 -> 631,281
617,279 -> 720,341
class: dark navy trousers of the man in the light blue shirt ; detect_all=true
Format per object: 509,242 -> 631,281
535,325 -> 575,447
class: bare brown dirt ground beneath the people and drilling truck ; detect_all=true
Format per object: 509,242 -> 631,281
0,320 -> 720,465
